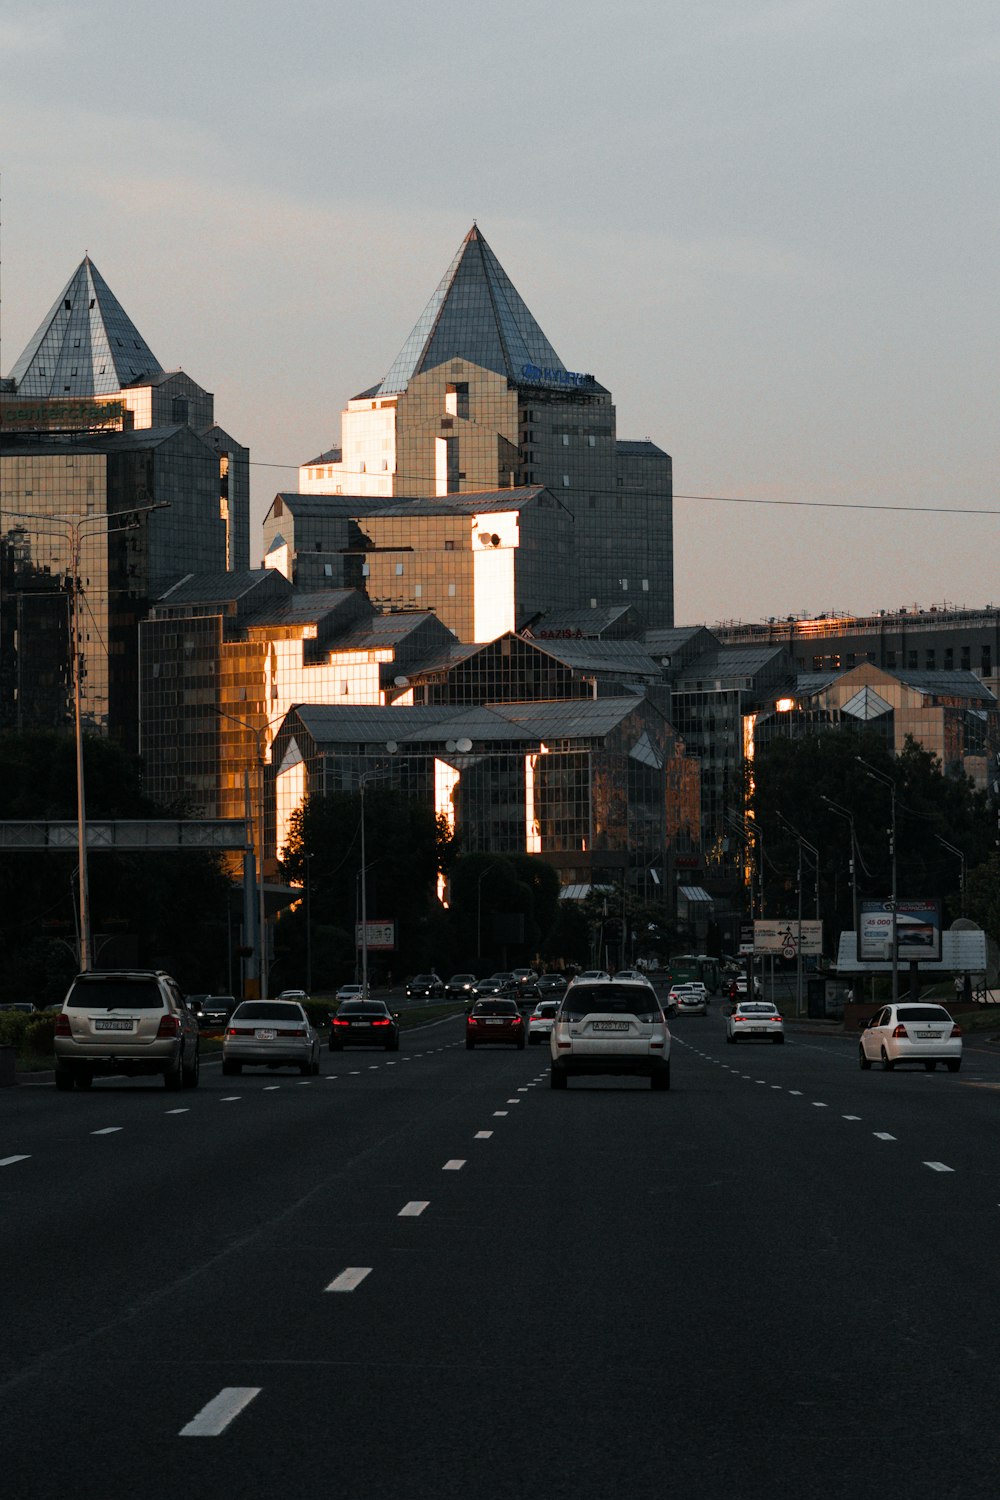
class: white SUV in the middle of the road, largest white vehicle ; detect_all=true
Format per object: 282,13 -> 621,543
549,980 -> 670,1089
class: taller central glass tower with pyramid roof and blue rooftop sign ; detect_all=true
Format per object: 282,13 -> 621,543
298,225 -> 673,639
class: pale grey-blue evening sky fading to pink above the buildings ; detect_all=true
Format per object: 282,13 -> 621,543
0,0 -> 1000,626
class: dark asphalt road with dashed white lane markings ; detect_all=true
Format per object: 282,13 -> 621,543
0,1005 -> 1000,1500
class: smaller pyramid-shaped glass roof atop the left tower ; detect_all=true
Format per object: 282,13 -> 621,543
10,255 -> 162,398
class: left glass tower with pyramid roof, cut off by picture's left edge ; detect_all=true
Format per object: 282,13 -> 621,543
0,258 -> 249,749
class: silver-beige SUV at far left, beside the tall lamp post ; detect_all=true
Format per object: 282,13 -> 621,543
55,969 -> 201,1089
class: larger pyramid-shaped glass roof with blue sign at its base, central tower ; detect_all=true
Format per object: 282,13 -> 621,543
378,225 -> 565,396
